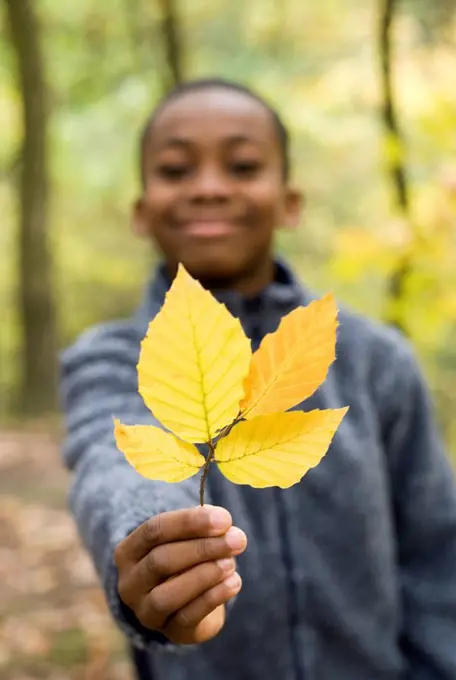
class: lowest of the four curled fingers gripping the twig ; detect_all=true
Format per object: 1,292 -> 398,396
169,572 -> 242,635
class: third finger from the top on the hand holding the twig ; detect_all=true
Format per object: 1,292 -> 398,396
137,560 -> 234,630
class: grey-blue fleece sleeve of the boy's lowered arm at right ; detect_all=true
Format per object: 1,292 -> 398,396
383,340 -> 456,680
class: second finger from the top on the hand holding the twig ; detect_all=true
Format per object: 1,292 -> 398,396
131,527 -> 247,593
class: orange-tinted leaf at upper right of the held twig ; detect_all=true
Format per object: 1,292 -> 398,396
241,295 -> 337,419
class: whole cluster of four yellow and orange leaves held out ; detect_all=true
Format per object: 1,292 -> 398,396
114,266 -> 347,500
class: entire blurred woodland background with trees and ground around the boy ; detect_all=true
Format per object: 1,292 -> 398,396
0,0 -> 456,680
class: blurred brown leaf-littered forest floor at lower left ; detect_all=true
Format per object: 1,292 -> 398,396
0,424 -> 132,680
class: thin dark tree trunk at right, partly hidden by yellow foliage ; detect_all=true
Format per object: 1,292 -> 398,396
379,0 -> 411,331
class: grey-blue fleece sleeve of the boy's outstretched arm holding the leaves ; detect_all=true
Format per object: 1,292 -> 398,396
61,324 -> 210,649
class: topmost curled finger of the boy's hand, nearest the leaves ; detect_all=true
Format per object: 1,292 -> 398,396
115,505 -> 232,566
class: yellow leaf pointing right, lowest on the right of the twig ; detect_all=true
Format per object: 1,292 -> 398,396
215,408 -> 348,489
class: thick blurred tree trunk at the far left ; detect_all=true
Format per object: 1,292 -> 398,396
5,0 -> 57,414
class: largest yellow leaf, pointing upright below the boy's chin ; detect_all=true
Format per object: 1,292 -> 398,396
138,265 -> 251,442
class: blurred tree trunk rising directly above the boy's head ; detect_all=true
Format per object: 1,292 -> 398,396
159,0 -> 184,91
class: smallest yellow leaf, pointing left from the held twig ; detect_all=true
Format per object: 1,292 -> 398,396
114,420 -> 205,482
